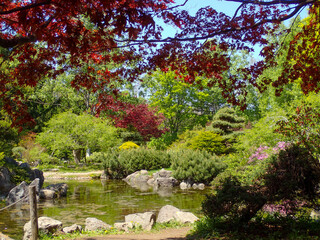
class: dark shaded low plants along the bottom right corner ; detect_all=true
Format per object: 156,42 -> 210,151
191,214 -> 320,240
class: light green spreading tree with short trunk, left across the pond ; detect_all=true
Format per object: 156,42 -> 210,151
37,112 -> 120,163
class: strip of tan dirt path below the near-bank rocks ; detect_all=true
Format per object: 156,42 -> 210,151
72,227 -> 191,240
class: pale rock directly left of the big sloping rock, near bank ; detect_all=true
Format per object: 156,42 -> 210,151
125,212 -> 156,231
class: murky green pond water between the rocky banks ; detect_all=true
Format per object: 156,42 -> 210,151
0,180 -> 209,239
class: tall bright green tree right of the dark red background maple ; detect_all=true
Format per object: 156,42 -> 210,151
144,71 -> 225,136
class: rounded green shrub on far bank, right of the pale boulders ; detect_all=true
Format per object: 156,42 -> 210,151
169,149 -> 225,184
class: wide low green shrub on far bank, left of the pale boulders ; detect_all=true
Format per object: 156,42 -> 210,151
104,148 -> 171,179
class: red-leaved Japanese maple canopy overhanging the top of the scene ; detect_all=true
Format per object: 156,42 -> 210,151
0,0 -> 319,126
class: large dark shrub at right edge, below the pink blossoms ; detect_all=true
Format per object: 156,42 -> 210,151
203,145 -> 320,224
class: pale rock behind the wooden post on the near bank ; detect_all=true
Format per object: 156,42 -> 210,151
23,217 -> 62,240
